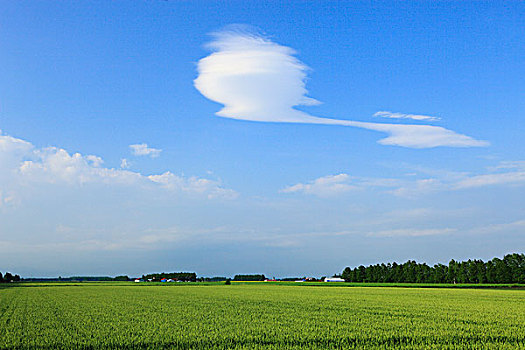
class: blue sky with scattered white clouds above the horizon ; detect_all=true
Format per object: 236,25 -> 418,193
0,1 -> 525,276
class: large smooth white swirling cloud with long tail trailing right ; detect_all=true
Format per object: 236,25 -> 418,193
194,31 -> 488,148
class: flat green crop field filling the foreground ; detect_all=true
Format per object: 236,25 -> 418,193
0,282 -> 525,349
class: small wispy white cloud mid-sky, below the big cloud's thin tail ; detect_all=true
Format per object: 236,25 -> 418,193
281,174 -> 357,197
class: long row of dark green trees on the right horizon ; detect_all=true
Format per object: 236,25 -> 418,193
341,254 -> 525,283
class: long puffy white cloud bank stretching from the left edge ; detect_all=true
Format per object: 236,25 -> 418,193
0,134 -> 237,203
